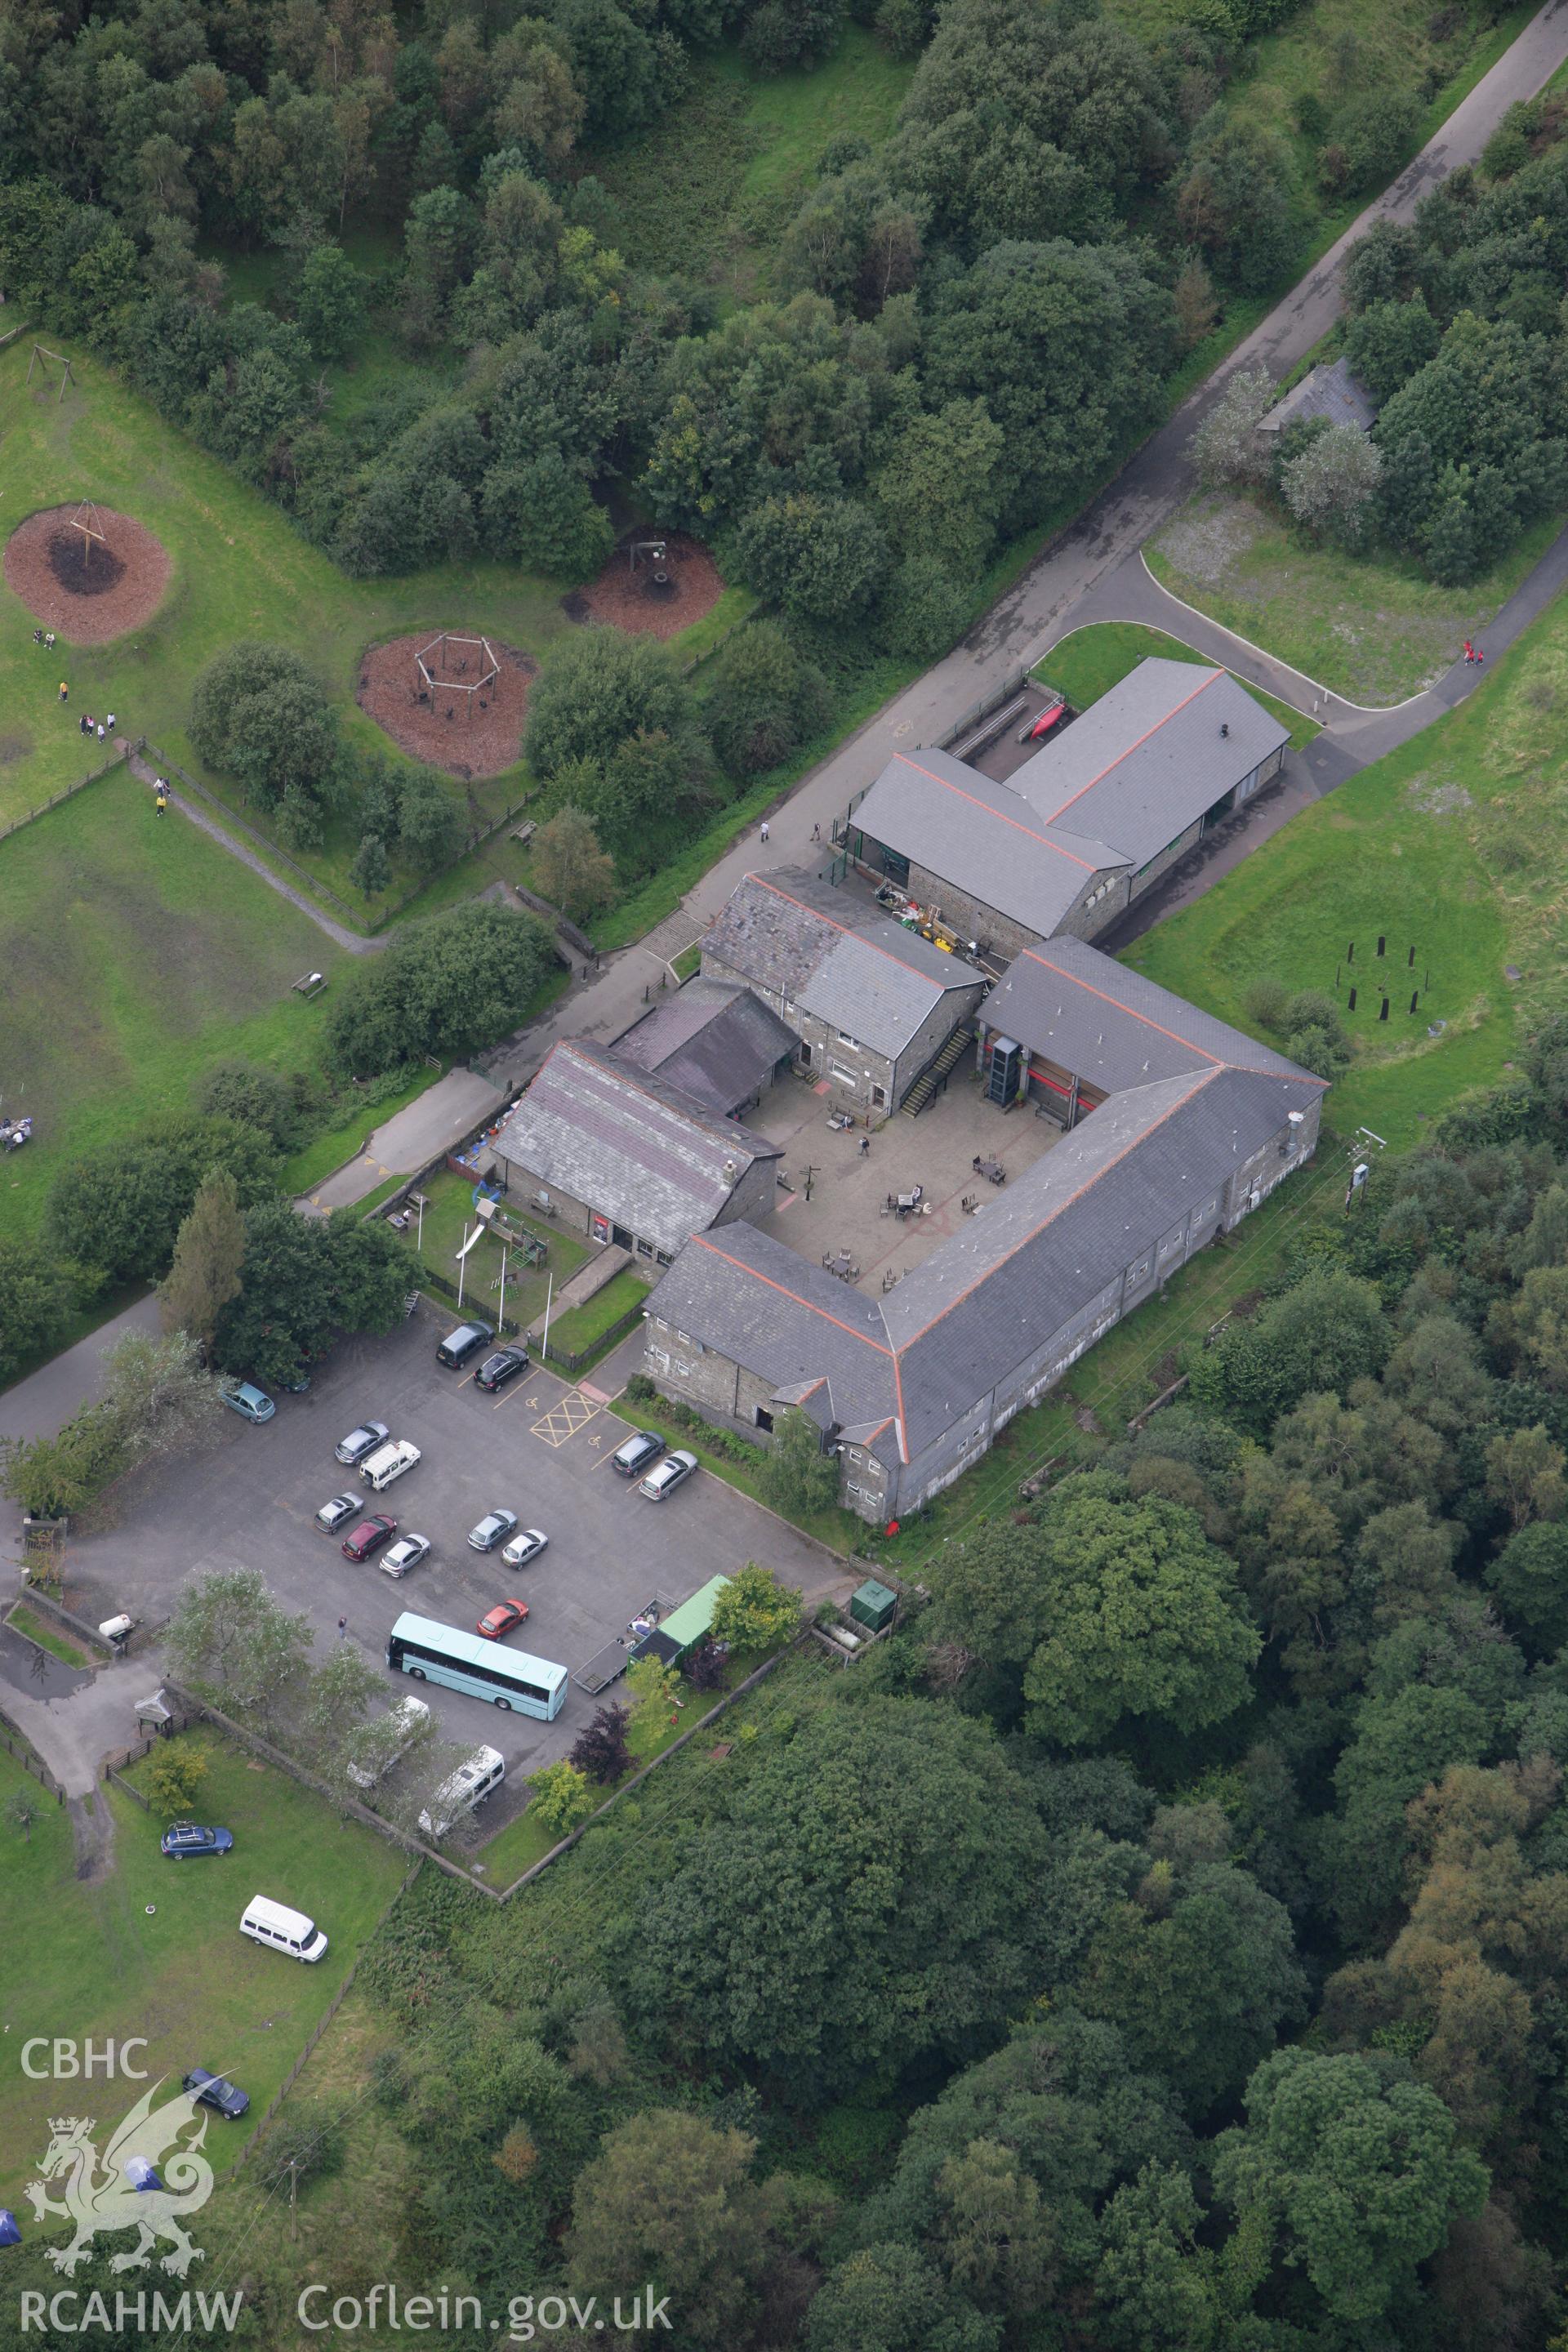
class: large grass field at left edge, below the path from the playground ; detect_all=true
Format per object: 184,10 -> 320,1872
0,771 -> 343,1232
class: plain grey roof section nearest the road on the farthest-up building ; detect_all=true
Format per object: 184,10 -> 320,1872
851,751 -> 1126,933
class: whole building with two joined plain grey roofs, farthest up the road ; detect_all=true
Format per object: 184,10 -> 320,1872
840,658 -> 1290,962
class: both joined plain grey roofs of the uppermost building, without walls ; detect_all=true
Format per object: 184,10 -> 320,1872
851,661 -> 1290,938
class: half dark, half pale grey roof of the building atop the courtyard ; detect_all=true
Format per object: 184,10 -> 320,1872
703,866 -> 980,1061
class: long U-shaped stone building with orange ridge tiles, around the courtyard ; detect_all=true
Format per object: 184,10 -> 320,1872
644,941 -> 1324,1524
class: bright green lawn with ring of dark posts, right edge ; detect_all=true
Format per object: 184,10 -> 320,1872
1129,578 -> 1568,1143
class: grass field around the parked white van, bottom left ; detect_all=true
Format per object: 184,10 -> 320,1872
0,1738 -> 404,2204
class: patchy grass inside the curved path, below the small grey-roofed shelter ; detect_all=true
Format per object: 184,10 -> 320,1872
1143,492 -> 1558,706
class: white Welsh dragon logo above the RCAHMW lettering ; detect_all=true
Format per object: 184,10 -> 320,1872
26,2077 -> 212,2279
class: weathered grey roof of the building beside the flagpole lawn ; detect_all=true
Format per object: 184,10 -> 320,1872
493,1037 -> 780,1260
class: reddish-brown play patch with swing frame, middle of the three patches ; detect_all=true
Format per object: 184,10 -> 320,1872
355,630 -> 538,783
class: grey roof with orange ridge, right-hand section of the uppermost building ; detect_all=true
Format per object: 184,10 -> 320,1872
1013,661 -> 1290,866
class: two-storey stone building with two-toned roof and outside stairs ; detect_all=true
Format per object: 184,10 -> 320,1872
703,866 -> 985,1110
